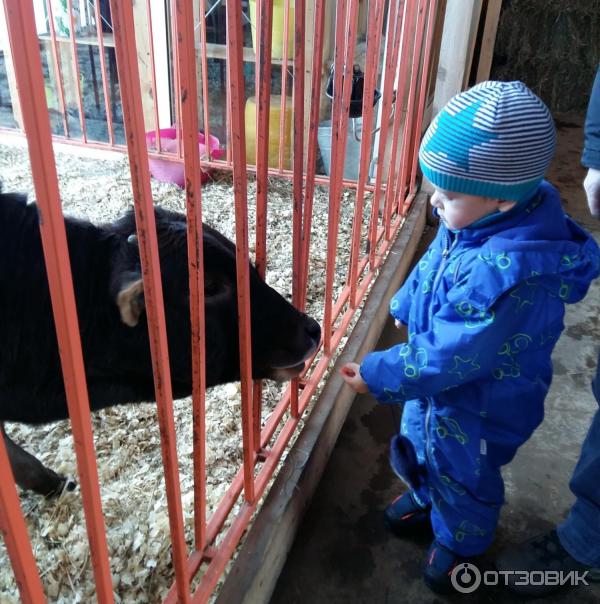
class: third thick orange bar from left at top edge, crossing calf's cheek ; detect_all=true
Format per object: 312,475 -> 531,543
175,1 -> 206,550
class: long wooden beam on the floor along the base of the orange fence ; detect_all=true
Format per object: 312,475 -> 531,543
217,193 -> 427,604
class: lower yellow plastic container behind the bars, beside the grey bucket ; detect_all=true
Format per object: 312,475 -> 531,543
246,94 -> 292,170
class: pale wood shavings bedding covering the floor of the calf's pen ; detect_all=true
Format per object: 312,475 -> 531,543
0,145 -> 370,604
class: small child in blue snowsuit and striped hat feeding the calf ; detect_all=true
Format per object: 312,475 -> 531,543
342,82 -> 600,592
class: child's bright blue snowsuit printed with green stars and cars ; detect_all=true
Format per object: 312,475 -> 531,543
360,182 -> 600,556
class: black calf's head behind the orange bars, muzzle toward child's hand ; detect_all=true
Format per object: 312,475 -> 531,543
111,208 -> 321,391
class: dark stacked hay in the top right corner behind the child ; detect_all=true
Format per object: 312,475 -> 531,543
491,0 -> 600,111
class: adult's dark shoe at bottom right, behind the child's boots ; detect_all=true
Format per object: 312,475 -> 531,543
496,530 -> 591,597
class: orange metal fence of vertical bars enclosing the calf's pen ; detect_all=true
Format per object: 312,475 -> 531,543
0,0 -> 438,602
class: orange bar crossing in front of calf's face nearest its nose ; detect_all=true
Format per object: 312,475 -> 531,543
227,0 -> 255,503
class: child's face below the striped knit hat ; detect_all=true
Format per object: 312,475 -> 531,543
431,187 -> 516,230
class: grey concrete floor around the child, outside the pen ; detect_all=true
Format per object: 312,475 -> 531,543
271,116 -> 600,604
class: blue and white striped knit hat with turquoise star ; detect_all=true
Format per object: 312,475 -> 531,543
419,82 -> 556,201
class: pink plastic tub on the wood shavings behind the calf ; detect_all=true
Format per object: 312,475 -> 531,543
146,128 -> 223,188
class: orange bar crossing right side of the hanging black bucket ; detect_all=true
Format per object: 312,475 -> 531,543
347,0 -> 384,308
